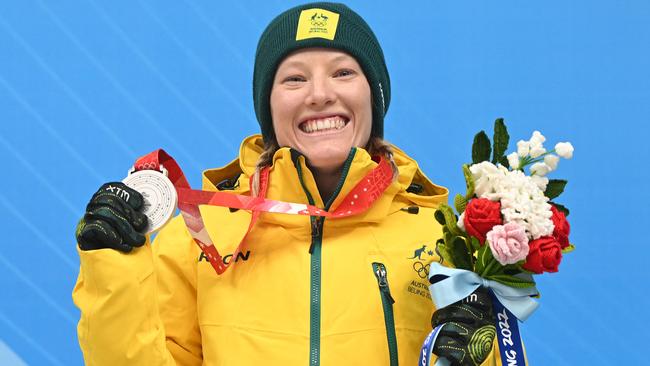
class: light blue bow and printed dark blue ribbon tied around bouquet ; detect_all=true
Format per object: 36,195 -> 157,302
418,263 -> 539,366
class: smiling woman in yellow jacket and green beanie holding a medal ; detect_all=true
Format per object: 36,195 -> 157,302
73,3 -> 499,366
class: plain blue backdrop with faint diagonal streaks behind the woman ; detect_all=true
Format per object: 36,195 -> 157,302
0,0 -> 650,365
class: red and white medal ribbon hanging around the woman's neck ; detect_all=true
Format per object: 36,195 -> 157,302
134,149 -> 393,274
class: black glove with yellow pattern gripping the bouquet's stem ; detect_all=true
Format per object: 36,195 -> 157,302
431,287 -> 496,366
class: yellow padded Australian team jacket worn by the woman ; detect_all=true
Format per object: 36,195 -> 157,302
73,135 -> 498,366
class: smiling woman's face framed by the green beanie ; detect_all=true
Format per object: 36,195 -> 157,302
271,48 -> 372,172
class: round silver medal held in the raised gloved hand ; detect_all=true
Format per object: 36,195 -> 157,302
122,166 -> 178,234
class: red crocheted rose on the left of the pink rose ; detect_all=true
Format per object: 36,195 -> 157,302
463,198 -> 503,244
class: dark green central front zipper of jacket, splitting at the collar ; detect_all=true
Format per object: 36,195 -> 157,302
296,148 -> 356,366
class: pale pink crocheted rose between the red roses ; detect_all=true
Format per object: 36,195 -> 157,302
485,222 -> 529,265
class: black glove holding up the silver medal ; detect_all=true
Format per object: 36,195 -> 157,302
75,182 -> 147,253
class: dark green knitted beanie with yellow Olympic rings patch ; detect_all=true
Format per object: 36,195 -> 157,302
253,2 -> 390,141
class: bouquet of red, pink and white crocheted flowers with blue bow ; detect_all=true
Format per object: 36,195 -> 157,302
418,119 -> 574,365
